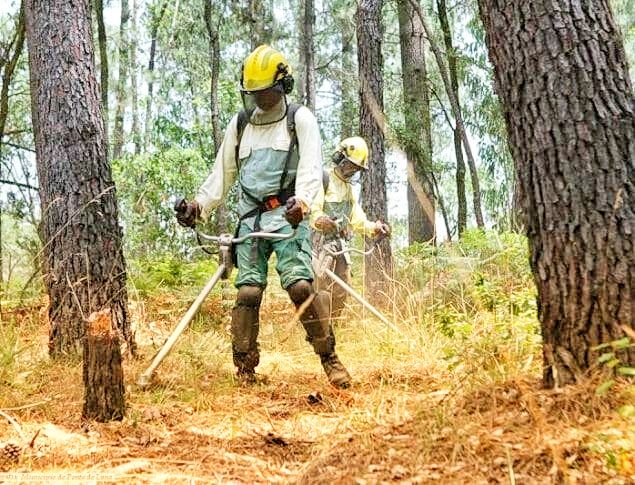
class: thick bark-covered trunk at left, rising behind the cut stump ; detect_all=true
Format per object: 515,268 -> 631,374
25,0 -> 134,356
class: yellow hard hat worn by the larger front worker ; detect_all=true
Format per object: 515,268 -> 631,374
240,44 -> 293,93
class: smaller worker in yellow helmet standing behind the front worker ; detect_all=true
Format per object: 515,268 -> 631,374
311,136 -> 390,319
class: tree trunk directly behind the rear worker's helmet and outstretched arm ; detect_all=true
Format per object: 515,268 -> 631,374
357,0 -> 392,301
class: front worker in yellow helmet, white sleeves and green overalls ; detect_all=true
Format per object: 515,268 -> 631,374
175,45 -> 351,387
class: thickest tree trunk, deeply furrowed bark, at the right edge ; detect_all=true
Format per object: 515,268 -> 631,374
479,0 -> 635,387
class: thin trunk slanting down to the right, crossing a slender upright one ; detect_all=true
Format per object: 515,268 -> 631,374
409,0 -> 485,228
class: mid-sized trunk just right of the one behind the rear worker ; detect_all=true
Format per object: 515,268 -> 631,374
397,0 -> 436,244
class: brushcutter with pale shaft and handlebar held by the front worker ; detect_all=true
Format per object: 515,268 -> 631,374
137,225 -> 296,387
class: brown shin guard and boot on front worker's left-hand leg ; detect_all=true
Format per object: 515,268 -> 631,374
232,286 -> 262,384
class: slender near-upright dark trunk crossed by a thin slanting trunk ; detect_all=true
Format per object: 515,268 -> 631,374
437,0 -> 467,238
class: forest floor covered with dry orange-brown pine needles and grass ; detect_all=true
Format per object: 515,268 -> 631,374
0,282 -> 635,484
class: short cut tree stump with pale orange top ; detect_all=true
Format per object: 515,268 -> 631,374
82,308 -> 125,422
